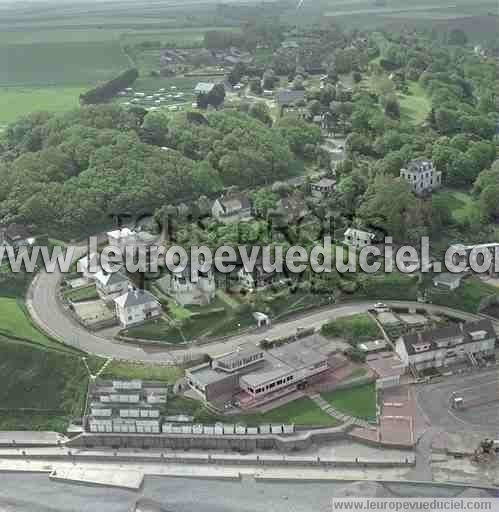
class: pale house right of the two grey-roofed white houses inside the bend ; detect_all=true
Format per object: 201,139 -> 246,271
157,266 -> 216,306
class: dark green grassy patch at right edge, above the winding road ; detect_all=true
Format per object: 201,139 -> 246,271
427,276 -> 499,313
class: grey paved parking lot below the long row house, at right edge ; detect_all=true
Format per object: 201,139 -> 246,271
417,368 -> 499,434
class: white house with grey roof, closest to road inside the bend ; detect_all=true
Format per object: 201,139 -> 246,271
114,289 -> 162,327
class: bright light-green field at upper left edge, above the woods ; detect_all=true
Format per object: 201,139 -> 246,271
0,85 -> 87,126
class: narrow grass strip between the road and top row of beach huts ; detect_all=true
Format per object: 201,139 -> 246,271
100,361 -> 185,384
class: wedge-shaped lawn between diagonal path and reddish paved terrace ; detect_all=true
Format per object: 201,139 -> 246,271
321,384 -> 376,420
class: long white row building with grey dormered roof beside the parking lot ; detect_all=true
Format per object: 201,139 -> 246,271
395,320 -> 497,371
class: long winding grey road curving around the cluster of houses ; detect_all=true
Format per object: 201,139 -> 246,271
27,247 -> 492,363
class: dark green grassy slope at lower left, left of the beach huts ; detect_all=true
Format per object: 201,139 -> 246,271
0,338 -> 88,430
